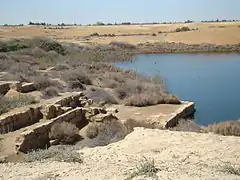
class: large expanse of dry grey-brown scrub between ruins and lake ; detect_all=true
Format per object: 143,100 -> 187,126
0,37 -> 180,107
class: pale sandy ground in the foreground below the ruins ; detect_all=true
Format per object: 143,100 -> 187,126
0,128 -> 240,180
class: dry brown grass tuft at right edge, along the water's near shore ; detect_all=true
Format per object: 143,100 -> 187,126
203,121 -> 240,136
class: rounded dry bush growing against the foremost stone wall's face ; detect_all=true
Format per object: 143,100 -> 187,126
49,122 -> 80,144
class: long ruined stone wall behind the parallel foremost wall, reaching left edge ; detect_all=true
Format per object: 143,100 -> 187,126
0,93 -> 89,134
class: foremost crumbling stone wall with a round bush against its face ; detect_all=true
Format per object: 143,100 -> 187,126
16,107 -> 88,153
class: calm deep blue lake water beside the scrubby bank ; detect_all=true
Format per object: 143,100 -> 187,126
116,54 -> 240,125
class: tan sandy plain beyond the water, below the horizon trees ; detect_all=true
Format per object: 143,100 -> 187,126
0,22 -> 240,44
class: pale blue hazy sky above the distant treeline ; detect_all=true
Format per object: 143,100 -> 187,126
0,0 -> 240,24
